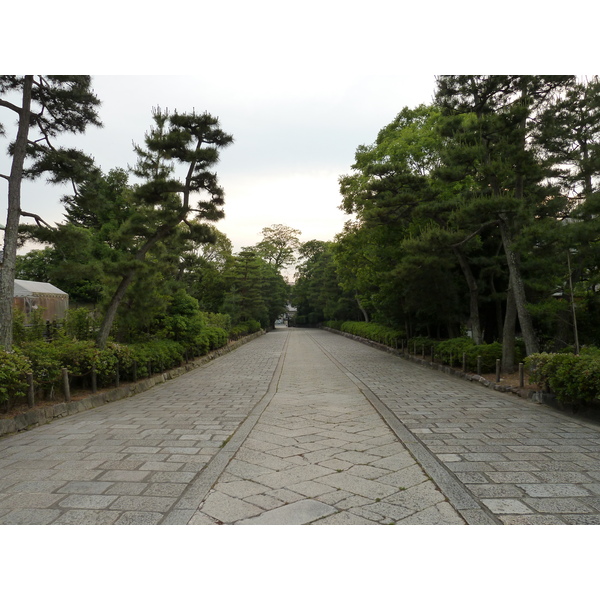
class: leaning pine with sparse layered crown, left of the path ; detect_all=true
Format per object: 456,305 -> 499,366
97,108 -> 233,348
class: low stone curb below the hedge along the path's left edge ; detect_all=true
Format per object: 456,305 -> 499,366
0,330 -> 266,437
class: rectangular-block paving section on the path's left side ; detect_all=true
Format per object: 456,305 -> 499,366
0,335 -> 285,524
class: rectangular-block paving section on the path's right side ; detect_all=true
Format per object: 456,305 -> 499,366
315,332 -> 600,525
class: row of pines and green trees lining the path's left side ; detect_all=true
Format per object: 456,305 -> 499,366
0,76 -> 290,351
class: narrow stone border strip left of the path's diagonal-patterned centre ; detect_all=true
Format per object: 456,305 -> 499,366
160,332 -> 290,525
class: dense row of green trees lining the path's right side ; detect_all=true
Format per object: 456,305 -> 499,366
294,75 -> 600,371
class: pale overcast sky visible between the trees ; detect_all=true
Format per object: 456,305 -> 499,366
2,67 -> 435,250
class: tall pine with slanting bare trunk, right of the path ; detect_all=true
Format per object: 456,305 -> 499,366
436,76 -> 573,363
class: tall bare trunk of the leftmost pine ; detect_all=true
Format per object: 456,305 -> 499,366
0,75 -> 33,352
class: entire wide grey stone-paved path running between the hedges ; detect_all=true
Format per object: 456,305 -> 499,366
0,329 -> 600,524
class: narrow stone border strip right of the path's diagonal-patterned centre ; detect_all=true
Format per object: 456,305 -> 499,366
310,336 -> 502,525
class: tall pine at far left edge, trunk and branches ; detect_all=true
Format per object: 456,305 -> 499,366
0,75 -> 100,350
